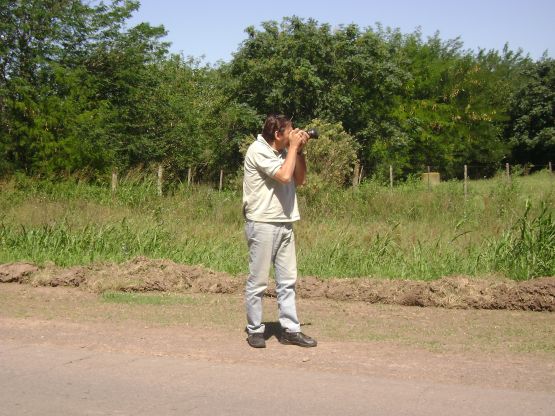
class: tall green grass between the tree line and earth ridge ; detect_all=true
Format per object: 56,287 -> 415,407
0,172 -> 555,279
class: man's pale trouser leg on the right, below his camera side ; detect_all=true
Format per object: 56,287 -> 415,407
274,223 -> 301,332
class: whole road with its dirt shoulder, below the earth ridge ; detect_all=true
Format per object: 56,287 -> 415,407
0,284 -> 555,416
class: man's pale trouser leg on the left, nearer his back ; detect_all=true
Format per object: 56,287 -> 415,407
245,221 -> 277,334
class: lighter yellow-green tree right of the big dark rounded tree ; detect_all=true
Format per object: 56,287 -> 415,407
372,31 -> 526,177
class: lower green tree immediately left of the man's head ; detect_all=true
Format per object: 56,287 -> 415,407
150,56 -> 260,179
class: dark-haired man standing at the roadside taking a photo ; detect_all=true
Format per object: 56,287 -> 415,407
243,115 -> 316,348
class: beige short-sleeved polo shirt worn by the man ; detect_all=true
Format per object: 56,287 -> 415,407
243,134 -> 301,222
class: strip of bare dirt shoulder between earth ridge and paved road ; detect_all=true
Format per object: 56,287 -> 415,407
0,283 -> 555,392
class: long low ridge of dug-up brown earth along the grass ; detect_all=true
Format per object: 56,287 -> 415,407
0,257 -> 555,312
